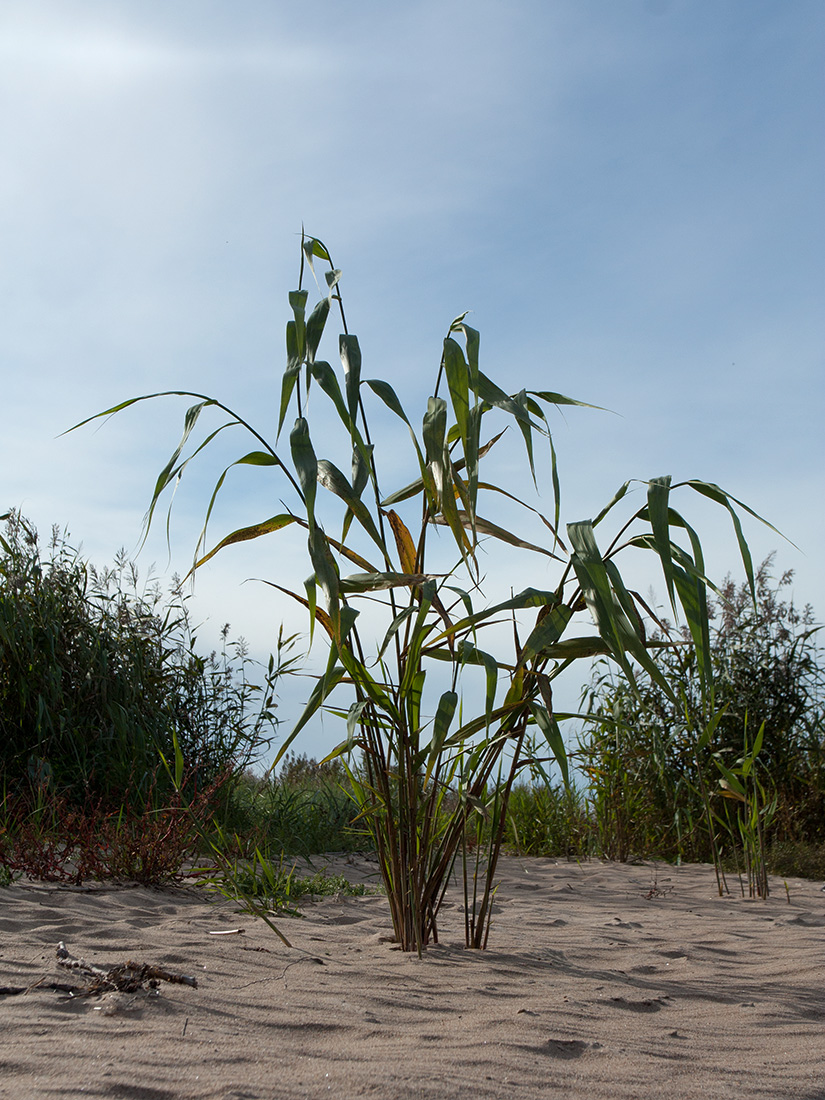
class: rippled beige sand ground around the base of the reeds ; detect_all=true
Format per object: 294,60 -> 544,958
0,857 -> 825,1100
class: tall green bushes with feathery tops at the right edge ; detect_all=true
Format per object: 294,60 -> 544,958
579,556 -> 825,859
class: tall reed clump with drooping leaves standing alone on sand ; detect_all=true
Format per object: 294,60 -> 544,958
77,235 -> 774,953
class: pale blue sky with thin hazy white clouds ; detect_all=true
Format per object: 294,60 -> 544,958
0,0 -> 825,770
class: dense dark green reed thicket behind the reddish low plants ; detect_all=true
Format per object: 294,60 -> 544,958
0,513 -> 288,803
